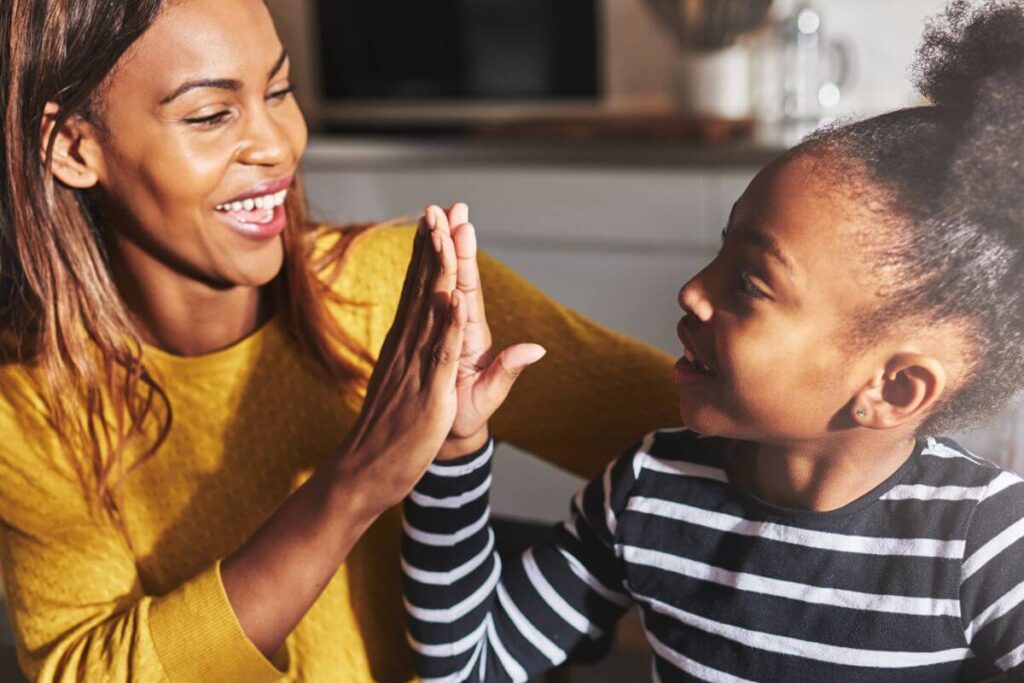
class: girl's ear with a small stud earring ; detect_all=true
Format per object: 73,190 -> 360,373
850,352 -> 947,429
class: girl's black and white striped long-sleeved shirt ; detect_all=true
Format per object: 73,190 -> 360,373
402,430 -> 1024,682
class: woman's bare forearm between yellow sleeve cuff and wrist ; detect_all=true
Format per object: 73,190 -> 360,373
220,463 -> 383,656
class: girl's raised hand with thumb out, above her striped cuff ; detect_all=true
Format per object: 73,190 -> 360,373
427,203 -> 546,460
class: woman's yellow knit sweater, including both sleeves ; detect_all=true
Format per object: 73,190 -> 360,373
0,227 -> 678,683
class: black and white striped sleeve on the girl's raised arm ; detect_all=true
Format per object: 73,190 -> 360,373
402,443 -> 634,681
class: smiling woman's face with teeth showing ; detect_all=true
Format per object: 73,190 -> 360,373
88,0 -> 306,289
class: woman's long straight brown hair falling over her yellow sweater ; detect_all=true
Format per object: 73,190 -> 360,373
0,0 -> 369,528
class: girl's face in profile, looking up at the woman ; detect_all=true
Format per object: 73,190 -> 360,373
676,157 -> 877,443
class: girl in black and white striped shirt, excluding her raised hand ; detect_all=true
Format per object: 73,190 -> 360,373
403,2 -> 1024,681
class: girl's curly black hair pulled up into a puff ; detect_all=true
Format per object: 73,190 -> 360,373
793,0 -> 1024,434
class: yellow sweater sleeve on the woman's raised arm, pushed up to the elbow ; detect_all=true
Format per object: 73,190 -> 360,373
0,387 -> 283,683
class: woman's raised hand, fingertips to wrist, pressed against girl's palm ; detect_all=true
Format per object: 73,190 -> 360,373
331,209 -> 468,511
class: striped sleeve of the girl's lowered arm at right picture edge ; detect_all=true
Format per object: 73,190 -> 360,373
961,472 -> 1024,681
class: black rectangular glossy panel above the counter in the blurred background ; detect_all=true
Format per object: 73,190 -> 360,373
317,0 -> 600,101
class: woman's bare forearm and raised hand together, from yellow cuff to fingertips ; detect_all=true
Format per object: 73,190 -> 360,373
220,214 -> 468,656
